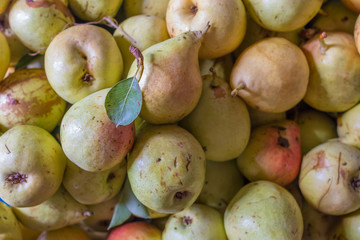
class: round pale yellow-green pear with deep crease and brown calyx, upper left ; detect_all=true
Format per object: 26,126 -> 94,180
45,25 -> 123,104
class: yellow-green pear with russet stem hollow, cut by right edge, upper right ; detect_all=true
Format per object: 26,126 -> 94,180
302,32 -> 360,112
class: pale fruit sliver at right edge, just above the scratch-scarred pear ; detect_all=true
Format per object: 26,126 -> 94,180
337,104 -> 360,148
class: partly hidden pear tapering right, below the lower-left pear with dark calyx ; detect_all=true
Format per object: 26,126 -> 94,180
13,187 -> 92,231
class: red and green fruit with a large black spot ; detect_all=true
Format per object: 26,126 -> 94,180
237,120 -> 301,186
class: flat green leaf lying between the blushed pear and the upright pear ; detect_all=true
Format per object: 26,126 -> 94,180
105,77 -> 142,126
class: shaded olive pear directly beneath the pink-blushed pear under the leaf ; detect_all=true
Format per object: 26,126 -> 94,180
63,161 -> 126,205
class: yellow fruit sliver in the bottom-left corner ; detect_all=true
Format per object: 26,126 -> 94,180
0,201 -> 23,240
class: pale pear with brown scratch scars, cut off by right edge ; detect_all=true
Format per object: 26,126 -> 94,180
299,140 -> 360,215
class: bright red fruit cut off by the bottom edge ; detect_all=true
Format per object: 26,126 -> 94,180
107,221 -> 162,240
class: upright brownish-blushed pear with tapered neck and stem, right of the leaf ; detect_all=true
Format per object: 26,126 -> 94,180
128,25 -> 210,124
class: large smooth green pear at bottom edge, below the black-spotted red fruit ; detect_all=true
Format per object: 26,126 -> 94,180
224,181 -> 303,240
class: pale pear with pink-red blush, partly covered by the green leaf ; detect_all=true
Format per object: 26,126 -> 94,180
60,88 -> 135,172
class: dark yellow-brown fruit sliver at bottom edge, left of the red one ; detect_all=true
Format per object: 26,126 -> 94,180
37,225 -> 91,240
